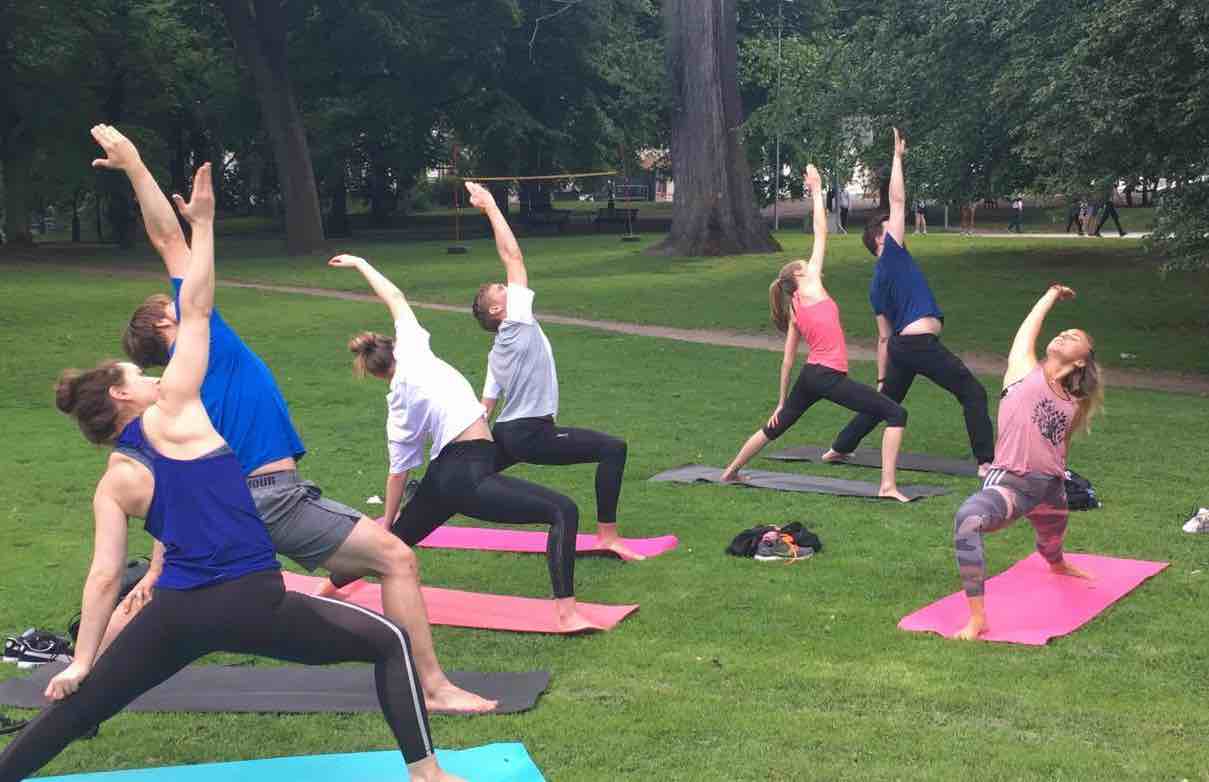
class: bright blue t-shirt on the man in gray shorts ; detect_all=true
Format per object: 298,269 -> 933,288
172,277 -> 306,475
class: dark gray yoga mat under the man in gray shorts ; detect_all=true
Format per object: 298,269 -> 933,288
0,662 -> 550,714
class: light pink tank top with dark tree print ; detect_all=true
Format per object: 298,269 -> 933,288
993,365 -> 1078,476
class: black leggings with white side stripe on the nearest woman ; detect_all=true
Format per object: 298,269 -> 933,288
0,570 -> 433,782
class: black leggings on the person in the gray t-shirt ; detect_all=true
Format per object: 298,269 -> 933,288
492,417 -> 626,525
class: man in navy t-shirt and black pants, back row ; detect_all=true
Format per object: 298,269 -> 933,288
823,128 -> 995,476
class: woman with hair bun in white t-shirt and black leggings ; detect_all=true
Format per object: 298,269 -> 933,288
324,255 -> 591,632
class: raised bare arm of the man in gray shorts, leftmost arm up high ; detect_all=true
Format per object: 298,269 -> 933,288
92,124 -> 189,277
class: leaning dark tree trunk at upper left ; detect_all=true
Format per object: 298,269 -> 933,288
220,0 -> 323,255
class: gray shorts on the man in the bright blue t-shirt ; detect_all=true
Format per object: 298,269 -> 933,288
248,470 -> 361,570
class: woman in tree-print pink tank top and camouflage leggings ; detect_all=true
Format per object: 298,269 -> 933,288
953,285 -> 1104,641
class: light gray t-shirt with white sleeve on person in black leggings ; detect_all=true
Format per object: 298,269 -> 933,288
482,284 -> 559,423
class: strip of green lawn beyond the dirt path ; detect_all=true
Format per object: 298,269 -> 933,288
14,231 -> 1209,373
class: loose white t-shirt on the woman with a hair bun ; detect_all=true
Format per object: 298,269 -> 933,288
386,318 -> 487,475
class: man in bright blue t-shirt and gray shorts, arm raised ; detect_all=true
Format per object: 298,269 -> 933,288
92,124 -> 496,712
